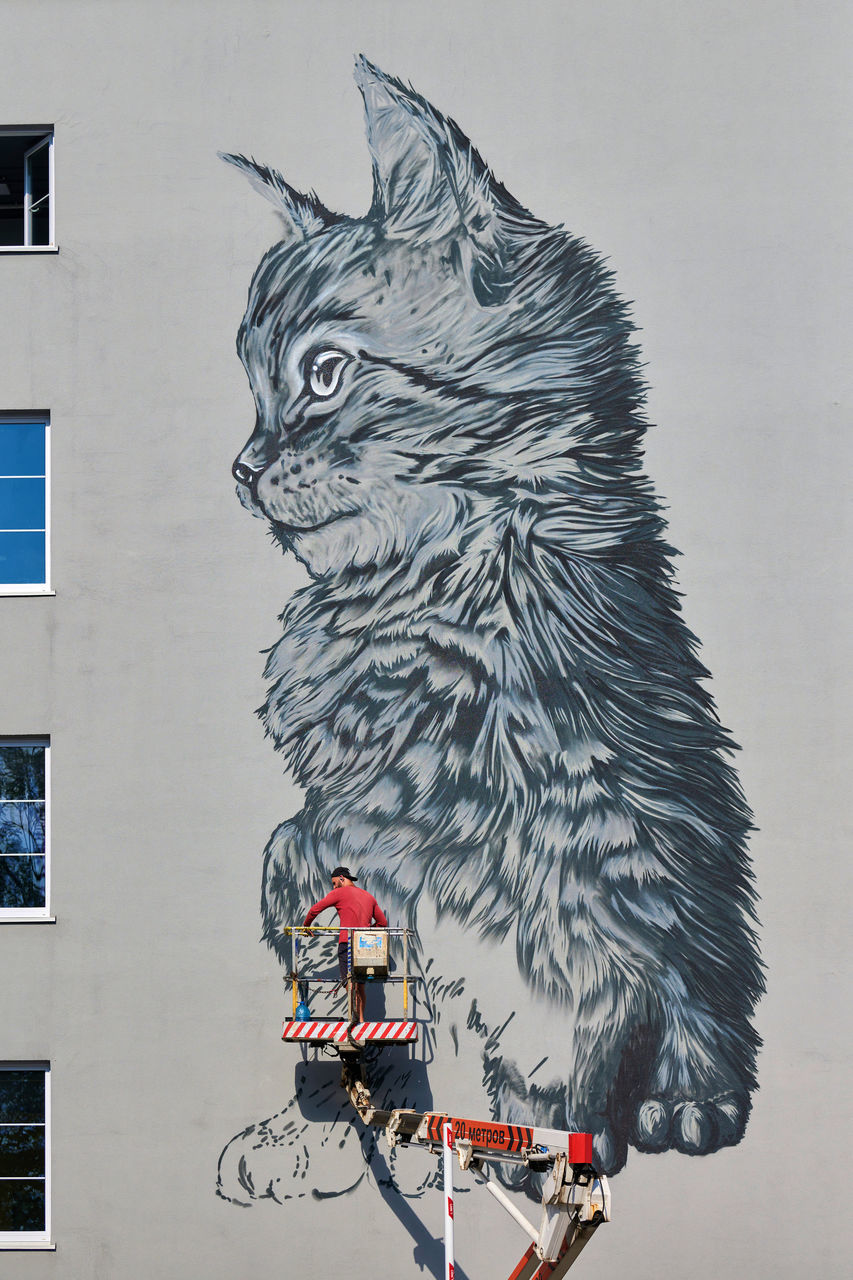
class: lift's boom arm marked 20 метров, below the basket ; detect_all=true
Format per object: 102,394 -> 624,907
341,1052 -> 610,1280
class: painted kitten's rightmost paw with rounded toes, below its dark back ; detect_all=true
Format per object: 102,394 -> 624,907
631,1092 -> 749,1156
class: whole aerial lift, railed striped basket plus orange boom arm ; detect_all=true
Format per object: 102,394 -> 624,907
282,925 -> 610,1280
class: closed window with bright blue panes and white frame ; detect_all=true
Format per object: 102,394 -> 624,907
0,413 -> 50,595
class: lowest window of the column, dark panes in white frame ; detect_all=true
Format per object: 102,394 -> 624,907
0,1062 -> 50,1248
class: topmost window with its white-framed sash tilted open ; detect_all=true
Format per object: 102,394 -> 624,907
0,125 -> 54,250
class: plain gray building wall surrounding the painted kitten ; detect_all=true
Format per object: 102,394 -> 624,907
0,0 -> 850,1280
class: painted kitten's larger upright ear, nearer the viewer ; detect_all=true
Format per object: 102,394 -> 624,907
356,55 -> 511,306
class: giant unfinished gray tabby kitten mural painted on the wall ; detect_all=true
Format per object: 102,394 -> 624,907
220,59 -> 762,1199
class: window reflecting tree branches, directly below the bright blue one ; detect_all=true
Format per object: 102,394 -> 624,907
0,737 -> 50,920
